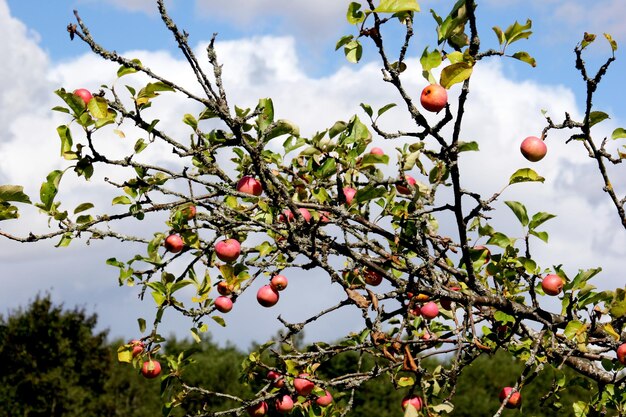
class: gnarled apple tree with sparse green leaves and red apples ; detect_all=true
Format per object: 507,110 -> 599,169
0,0 -> 626,416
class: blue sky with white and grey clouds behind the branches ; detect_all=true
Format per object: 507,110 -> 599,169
0,0 -> 626,347
